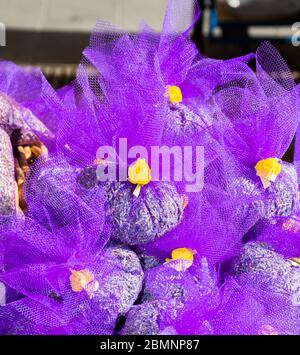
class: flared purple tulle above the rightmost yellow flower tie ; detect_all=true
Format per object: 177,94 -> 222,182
214,42 -> 299,167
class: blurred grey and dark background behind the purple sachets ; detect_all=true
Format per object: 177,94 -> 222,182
0,0 -> 300,87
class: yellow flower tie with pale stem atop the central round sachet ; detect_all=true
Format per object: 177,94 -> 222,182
128,158 -> 151,197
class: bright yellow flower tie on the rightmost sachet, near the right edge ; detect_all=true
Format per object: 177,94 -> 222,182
255,158 -> 281,189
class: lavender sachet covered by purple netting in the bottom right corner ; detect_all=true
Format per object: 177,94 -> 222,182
207,241 -> 300,335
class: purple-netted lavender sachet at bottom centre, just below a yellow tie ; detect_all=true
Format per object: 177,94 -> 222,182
121,255 -> 219,335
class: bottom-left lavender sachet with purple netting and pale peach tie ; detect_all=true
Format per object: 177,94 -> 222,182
0,242 -> 143,335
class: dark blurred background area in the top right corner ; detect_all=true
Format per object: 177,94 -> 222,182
193,0 -> 300,73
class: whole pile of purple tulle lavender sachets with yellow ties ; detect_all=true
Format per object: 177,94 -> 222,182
0,0 -> 300,335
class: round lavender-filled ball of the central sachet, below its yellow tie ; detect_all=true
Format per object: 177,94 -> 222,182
105,182 -> 183,245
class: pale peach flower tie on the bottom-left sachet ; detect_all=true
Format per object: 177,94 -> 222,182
70,269 -> 99,298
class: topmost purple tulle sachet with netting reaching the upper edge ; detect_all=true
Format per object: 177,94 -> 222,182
84,0 -> 253,149
